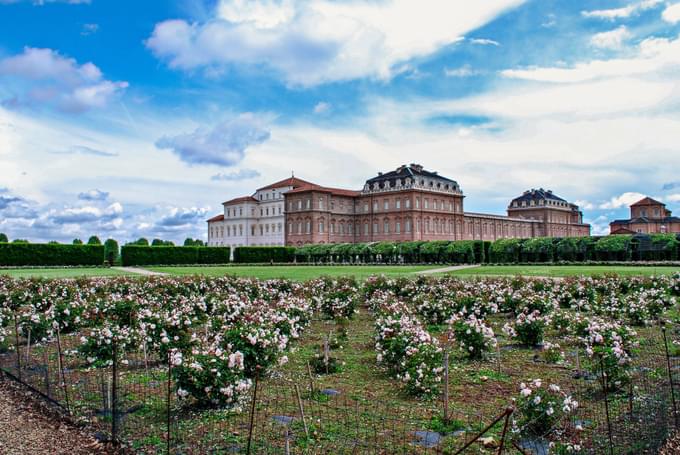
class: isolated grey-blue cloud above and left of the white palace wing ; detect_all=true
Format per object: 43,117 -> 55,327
156,114 -> 270,166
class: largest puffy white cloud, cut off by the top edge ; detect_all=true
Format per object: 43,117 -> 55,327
146,0 -> 523,86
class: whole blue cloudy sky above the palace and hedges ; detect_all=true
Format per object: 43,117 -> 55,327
0,0 -> 680,241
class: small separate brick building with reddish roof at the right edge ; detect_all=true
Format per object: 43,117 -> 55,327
609,197 -> 680,234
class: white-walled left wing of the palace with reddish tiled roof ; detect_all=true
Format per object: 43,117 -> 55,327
208,177 -> 311,248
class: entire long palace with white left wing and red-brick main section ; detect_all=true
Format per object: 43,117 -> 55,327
208,164 -> 590,246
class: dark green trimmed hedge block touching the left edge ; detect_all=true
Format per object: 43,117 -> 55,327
0,243 -> 104,266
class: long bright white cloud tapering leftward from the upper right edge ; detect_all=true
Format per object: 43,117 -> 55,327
501,37 -> 680,82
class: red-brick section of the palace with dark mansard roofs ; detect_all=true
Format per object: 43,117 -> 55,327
284,164 -> 590,246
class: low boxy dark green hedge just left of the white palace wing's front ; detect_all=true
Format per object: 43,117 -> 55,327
120,245 -> 231,266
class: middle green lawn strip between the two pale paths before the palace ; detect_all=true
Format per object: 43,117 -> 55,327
146,265 -> 441,281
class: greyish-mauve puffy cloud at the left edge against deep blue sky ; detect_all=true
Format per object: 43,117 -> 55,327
0,47 -> 128,113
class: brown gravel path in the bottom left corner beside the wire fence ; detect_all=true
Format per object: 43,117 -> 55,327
0,373 -> 107,455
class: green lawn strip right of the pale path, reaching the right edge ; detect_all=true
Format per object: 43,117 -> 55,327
450,265 -> 680,277
